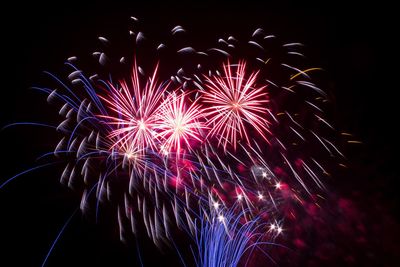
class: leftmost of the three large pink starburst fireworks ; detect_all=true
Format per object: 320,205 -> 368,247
100,62 -> 168,151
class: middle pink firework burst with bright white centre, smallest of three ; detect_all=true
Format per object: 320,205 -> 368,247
156,92 -> 206,157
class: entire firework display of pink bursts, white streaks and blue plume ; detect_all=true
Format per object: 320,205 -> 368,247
0,18 -> 345,267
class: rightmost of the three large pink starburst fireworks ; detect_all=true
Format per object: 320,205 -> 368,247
203,62 -> 269,150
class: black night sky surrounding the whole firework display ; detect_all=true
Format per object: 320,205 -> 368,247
0,1 -> 400,266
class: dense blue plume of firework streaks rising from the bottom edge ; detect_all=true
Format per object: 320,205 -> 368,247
191,209 -> 276,267
